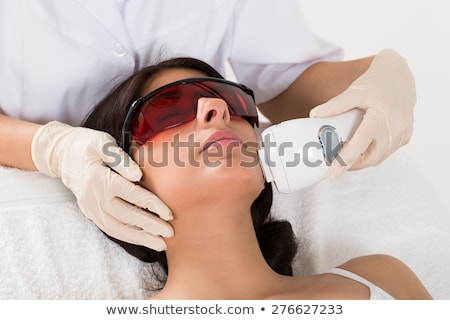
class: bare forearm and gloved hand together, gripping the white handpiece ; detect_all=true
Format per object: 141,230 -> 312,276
260,49 -> 416,179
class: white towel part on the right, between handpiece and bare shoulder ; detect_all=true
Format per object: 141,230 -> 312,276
273,150 -> 450,299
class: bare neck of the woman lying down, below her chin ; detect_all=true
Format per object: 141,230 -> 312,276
158,206 -> 281,299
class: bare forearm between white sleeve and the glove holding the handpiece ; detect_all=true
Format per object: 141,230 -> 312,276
258,56 -> 373,123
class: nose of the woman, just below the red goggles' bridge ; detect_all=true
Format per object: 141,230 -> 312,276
197,98 -> 230,126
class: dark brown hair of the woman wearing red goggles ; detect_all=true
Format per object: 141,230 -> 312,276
84,58 -> 297,288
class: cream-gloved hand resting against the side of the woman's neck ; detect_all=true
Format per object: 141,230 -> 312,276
31,121 -> 173,251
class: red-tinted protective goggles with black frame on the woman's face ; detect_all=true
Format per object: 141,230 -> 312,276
120,77 -> 258,152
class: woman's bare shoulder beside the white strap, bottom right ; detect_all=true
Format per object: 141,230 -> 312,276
339,254 -> 432,300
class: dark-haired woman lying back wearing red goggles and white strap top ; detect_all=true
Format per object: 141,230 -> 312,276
81,58 -> 431,300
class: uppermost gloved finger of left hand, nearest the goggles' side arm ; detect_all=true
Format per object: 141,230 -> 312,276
101,139 -> 142,182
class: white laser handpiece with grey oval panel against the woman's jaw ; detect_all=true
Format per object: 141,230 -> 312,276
258,109 -> 364,193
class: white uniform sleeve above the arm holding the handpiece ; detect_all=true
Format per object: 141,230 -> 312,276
230,0 -> 343,103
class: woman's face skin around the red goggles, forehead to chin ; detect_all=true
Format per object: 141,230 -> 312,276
133,69 -> 264,212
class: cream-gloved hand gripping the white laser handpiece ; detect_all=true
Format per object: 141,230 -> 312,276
310,49 -> 416,180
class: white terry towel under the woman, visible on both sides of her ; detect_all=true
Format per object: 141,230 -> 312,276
0,152 -> 450,299
